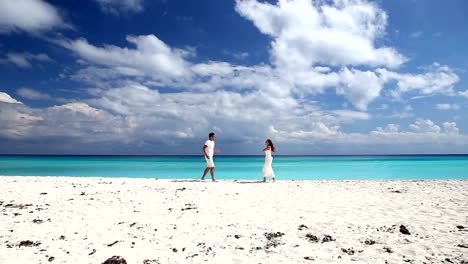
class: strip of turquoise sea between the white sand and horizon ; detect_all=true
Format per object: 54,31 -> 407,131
0,155 -> 468,180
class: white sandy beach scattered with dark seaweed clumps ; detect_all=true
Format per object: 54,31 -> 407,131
0,176 -> 468,264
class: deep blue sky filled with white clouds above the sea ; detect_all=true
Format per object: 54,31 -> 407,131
0,0 -> 468,155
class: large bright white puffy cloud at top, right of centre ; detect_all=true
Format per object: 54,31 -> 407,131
236,0 -> 406,68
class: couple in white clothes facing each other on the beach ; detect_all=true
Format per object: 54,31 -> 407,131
201,132 -> 276,182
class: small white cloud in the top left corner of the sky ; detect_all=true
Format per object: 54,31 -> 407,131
0,0 -> 69,33
